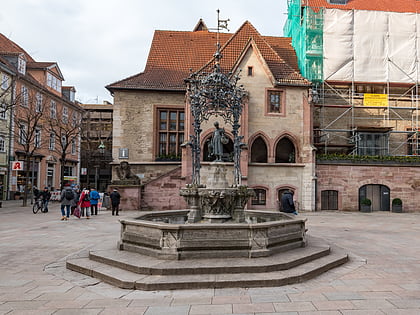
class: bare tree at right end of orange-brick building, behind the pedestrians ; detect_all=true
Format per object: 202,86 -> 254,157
48,105 -> 82,189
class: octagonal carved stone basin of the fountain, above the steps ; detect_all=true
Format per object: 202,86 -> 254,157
118,210 -> 306,260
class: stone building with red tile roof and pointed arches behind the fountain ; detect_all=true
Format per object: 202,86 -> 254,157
106,20 -> 314,210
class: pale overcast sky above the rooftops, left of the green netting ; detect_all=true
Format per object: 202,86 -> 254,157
0,0 -> 287,103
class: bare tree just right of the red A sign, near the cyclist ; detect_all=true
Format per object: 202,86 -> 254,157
13,90 -> 46,206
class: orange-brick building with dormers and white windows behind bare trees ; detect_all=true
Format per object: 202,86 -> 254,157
0,34 -> 84,198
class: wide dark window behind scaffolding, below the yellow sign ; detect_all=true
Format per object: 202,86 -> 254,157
356,132 -> 389,155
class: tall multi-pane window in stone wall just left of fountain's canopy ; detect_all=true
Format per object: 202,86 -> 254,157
157,109 -> 185,159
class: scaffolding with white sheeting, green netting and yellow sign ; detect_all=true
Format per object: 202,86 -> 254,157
284,0 -> 420,156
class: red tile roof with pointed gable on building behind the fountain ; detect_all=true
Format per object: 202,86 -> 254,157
106,22 -> 308,92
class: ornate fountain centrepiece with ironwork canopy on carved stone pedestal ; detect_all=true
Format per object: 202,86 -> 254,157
180,40 -> 254,223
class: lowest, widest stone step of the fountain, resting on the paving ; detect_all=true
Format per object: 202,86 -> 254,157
66,252 -> 348,291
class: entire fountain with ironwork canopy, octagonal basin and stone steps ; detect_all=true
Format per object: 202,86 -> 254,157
67,12 -> 348,290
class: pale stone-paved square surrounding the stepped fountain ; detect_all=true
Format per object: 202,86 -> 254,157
0,201 -> 420,315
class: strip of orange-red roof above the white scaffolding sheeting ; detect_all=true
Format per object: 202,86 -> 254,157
302,0 -> 420,13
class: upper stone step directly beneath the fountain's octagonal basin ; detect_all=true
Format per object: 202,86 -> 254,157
89,246 -> 330,275
